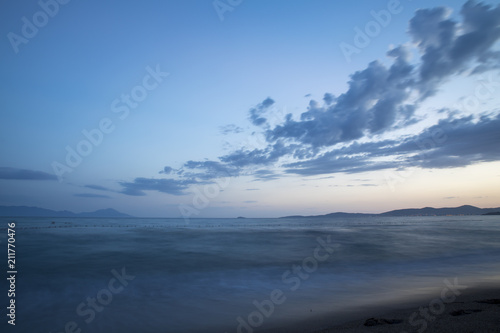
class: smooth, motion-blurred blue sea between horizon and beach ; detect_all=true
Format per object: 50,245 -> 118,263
0,216 -> 500,333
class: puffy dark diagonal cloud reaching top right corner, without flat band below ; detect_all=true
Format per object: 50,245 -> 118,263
266,1 -> 500,147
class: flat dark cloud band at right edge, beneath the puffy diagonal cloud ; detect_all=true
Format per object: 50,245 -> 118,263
285,114 -> 500,175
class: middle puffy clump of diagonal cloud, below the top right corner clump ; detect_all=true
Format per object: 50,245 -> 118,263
266,46 -> 415,148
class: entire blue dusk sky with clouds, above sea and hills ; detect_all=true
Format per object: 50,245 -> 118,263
0,0 -> 500,218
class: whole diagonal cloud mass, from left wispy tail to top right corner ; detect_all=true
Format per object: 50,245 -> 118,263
123,1 -> 500,195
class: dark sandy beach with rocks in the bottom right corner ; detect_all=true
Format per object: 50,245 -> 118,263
255,283 -> 500,333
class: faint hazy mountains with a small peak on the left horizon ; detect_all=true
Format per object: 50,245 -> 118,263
0,206 -> 133,217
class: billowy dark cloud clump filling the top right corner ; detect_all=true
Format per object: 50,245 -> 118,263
409,1 -> 500,97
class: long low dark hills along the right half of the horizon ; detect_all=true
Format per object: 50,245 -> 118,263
282,205 -> 500,218
